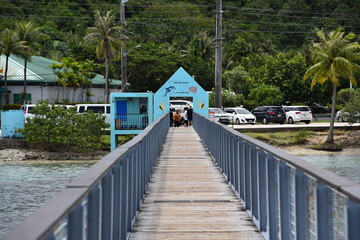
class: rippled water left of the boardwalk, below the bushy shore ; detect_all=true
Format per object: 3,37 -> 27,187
0,161 -> 93,238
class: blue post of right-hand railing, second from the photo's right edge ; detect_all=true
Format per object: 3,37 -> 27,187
316,183 -> 332,240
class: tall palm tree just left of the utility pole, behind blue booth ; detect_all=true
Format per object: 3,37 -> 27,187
85,11 -> 123,103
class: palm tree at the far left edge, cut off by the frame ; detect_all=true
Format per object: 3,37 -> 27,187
0,28 -> 28,104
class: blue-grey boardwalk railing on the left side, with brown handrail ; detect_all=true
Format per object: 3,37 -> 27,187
3,114 -> 169,240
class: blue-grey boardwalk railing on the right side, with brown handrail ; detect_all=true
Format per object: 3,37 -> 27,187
194,113 -> 360,240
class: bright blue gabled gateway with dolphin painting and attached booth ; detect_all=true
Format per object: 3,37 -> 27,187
110,68 -> 209,151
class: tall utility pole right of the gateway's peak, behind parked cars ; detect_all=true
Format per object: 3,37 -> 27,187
215,0 -> 222,108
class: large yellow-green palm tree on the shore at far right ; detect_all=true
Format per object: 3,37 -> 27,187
304,30 -> 360,144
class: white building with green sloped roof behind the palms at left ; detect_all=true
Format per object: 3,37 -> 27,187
0,55 -> 121,105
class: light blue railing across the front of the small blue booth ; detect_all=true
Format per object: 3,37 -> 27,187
115,113 -> 149,130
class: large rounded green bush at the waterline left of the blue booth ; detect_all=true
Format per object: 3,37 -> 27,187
19,101 -> 108,152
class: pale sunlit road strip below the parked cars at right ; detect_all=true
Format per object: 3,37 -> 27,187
228,122 -> 360,131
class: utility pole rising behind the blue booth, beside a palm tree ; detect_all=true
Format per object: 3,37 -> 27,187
120,0 -> 128,92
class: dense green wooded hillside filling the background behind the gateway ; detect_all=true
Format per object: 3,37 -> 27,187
0,0 -> 360,108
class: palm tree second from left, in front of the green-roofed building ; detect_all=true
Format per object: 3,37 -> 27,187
16,22 -> 47,103
